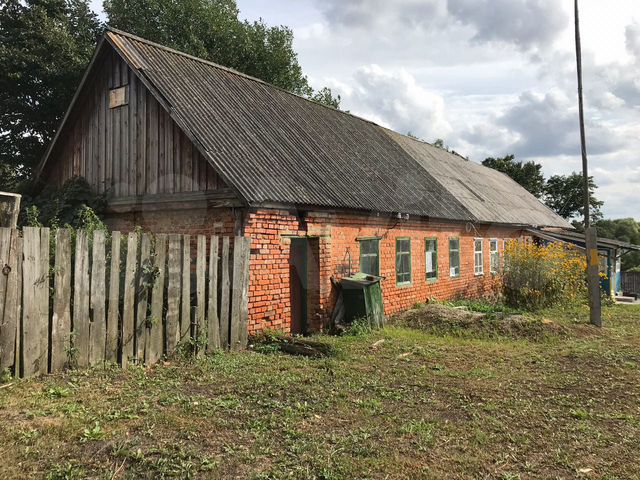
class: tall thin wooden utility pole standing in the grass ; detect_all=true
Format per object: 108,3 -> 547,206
574,0 -> 602,327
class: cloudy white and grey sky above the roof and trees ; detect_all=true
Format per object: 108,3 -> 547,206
93,0 -> 640,219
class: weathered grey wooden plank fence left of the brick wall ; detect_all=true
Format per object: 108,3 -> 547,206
0,228 -> 250,377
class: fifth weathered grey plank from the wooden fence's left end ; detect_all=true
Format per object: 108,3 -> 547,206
89,230 -> 107,365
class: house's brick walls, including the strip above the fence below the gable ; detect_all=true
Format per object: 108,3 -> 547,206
100,207 -> 522,332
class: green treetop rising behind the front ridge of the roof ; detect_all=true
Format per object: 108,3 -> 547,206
104,0 -> 340,108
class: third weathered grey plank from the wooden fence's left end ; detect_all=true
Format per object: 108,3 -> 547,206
51,228 -> 72,372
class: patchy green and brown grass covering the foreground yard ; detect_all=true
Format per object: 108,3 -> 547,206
0,306 -> 640,480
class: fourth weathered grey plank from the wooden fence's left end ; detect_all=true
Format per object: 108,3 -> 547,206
73,230 -> 90,367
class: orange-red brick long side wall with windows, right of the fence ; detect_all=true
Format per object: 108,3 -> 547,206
245,210 -> 521,331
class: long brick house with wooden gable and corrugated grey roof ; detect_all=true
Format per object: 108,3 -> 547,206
38,30 -> 571,333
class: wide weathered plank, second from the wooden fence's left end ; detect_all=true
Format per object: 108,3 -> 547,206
22,227 -> 49,377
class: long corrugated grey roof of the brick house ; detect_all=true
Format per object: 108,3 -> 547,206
40,29 -> 570,228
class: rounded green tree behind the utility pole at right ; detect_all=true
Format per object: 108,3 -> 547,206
544,172 -> 604,222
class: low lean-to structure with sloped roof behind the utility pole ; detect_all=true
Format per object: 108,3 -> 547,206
529,229 -> 640,297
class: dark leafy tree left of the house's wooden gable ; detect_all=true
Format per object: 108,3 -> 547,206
0,0 -> 101,190
